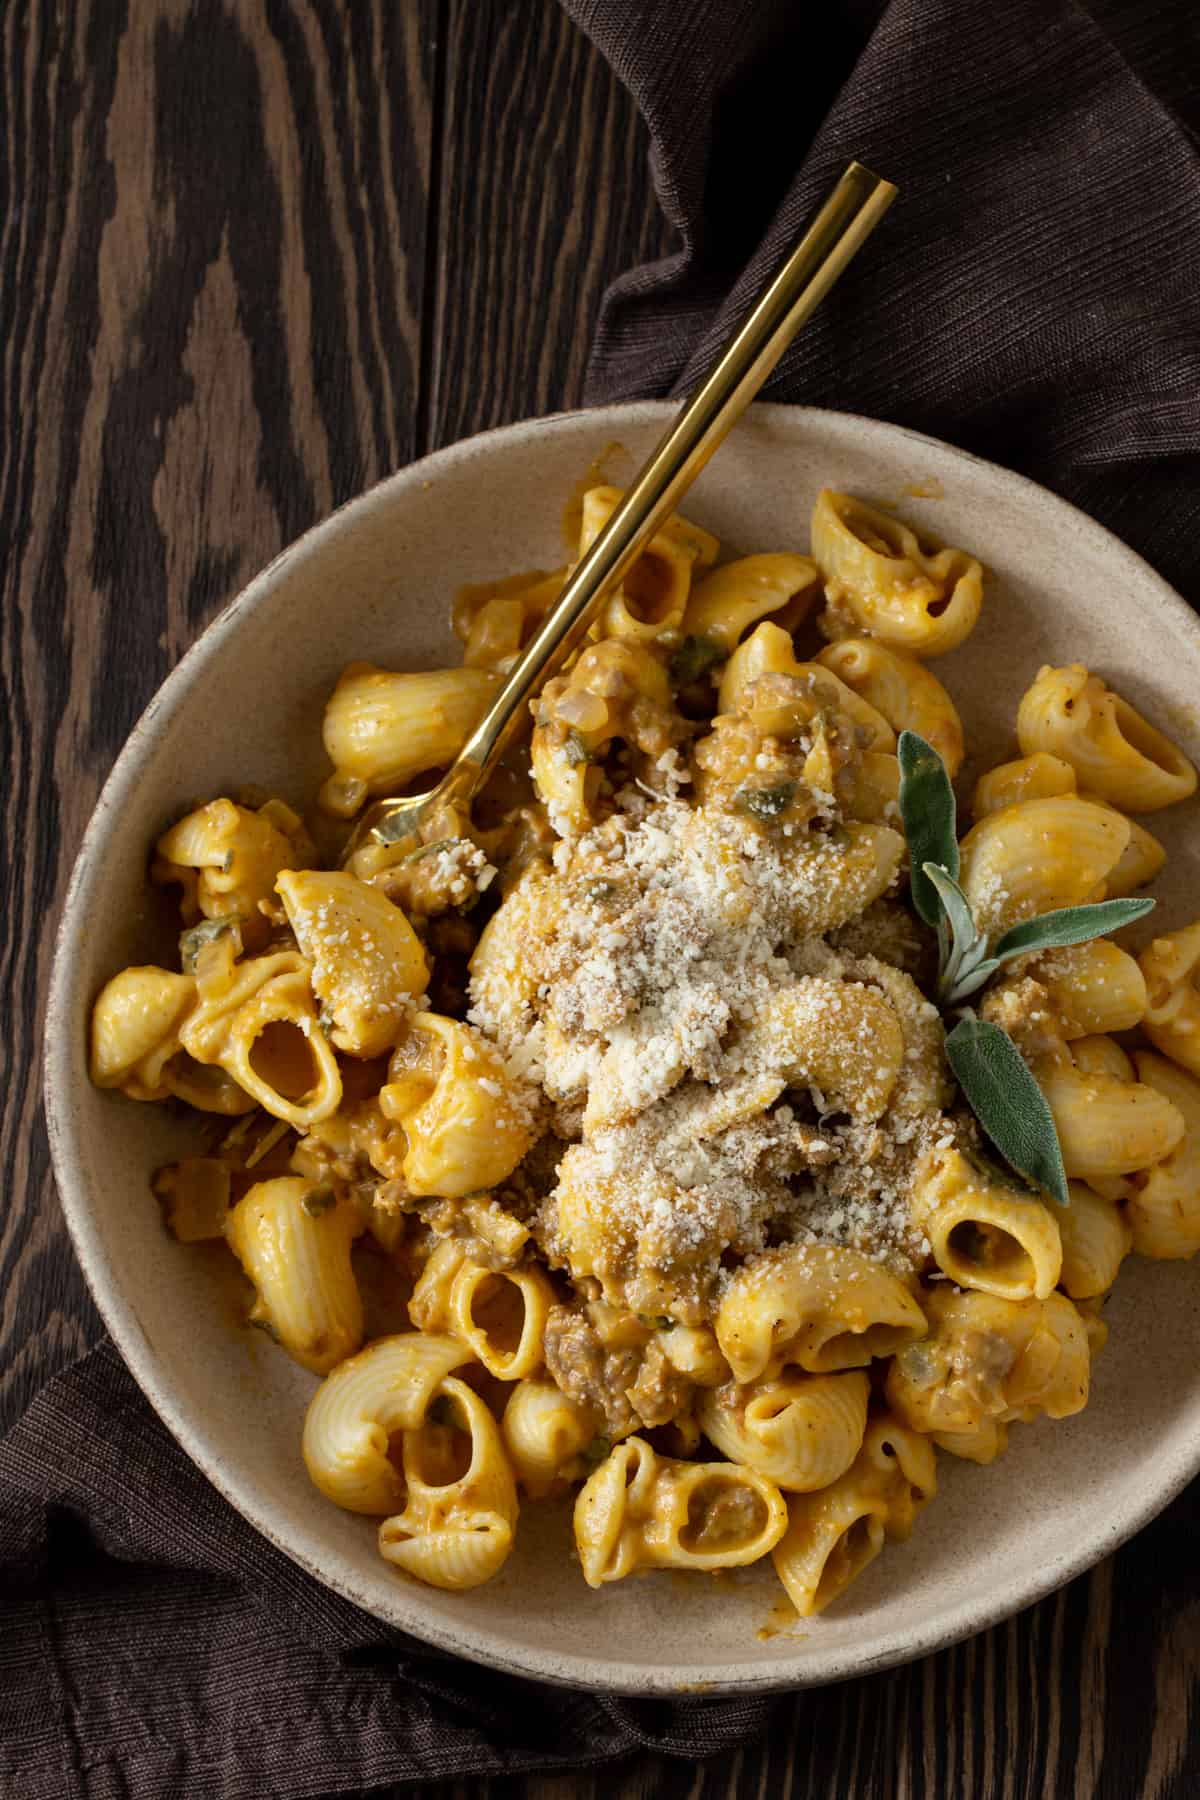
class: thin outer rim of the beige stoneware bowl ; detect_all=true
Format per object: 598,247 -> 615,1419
43,400 -> 1200,1697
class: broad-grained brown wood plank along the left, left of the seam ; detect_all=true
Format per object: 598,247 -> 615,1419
0,0 -> 439,1426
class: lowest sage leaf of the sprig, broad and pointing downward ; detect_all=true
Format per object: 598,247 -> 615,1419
946,1017 -> 1070,1206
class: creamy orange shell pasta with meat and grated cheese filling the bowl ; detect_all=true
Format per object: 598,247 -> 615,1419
90,486 -> 1200,1618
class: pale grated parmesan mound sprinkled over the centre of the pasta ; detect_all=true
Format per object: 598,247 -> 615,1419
470,792 -> 946,1323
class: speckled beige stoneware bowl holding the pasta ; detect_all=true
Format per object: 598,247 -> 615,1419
47,405 -> 1200,1694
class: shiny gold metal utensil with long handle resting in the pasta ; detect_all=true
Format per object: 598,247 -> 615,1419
344,162 -> 896,862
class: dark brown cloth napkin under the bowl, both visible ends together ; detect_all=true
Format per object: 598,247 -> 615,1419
9,0 -> 1200,1800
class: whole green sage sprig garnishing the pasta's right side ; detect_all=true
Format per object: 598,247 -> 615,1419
898,731 -> 1153,1206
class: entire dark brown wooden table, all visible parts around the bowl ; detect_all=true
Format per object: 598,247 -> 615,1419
0,0 -> 1200,1800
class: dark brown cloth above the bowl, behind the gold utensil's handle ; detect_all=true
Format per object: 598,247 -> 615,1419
567,0 -> 1200,603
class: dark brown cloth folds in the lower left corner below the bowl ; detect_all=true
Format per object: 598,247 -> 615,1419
0,1343 -> 770,1800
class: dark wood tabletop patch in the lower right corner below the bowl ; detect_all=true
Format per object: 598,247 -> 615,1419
399,1512 -> 1200,1800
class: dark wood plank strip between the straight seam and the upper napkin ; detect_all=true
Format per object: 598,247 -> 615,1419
428,0 -> 671,446
